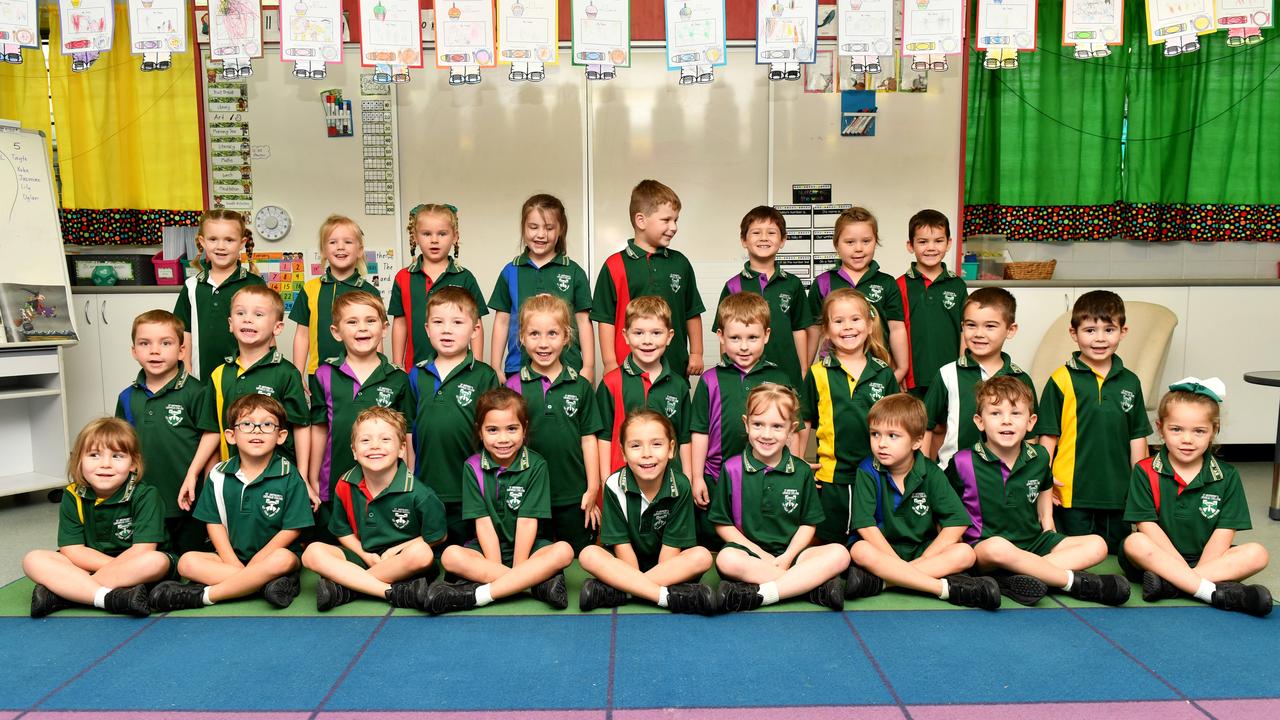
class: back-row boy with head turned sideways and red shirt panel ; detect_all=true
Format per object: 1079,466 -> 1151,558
591,179 -> 705,376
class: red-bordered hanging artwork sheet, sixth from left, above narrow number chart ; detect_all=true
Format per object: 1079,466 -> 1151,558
360,0 -> 422,85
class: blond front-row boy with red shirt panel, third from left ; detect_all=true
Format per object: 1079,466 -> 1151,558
302,405 -> 445,612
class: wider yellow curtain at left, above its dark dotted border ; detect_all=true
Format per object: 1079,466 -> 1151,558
46,4 -> 204,210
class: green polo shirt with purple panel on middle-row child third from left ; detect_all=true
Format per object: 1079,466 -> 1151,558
307,352 -> 415,500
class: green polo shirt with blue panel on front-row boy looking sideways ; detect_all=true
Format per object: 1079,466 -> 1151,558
852,451 -> 969,560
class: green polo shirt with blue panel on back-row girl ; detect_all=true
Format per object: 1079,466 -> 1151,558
489,251 -> 591,375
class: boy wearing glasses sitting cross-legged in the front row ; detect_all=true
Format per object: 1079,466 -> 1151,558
151,392 -> 315,611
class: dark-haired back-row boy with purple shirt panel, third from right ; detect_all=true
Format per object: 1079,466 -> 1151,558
712,205 -> 814,387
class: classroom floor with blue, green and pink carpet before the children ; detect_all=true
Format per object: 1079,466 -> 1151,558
0,464 -> 1280,720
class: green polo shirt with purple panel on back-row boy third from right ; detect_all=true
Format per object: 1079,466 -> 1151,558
712,263 -> 814,387
